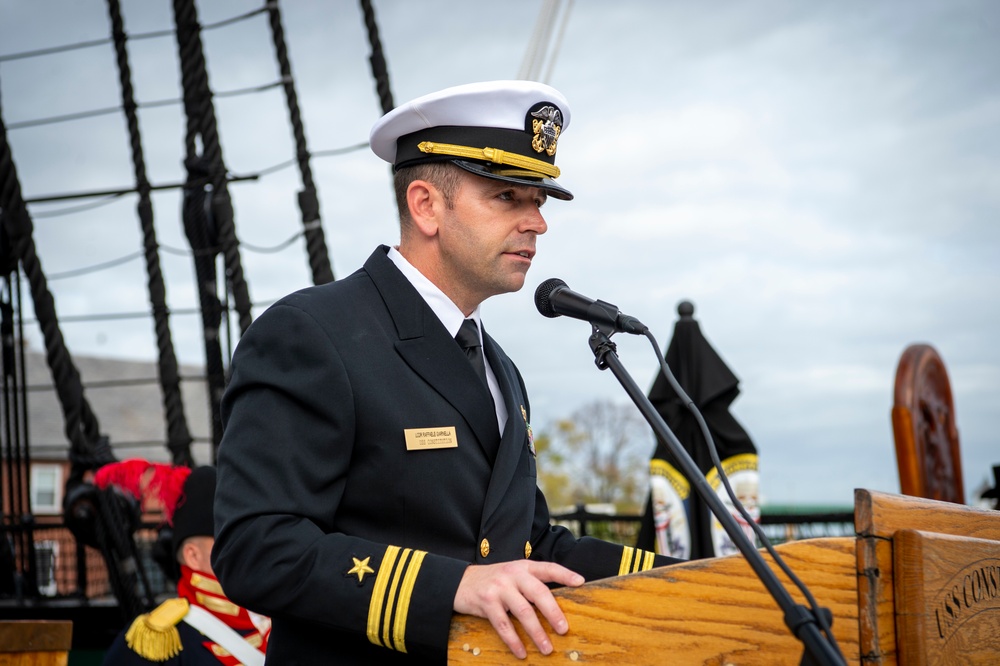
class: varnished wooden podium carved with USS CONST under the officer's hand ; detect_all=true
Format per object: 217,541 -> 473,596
448,490 -> 1000,666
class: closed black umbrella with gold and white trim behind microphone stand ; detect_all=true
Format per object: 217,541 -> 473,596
637,301 -> 759,559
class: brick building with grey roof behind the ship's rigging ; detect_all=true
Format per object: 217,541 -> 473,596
0,350 -> 213,599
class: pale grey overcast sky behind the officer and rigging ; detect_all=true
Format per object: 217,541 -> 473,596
0,0 -> 1000,506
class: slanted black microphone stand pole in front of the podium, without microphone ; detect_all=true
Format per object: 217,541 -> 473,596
590,324 -> 844,666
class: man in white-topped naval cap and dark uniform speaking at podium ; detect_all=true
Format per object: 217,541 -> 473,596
213,81 -> 671,664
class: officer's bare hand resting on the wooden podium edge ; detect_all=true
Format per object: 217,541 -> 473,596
455,560 -> 584,659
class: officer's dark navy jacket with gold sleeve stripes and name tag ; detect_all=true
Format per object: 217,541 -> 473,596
212,246 -> 672,665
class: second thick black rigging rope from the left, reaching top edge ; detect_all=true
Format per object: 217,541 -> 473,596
108,0 -> 194,467
